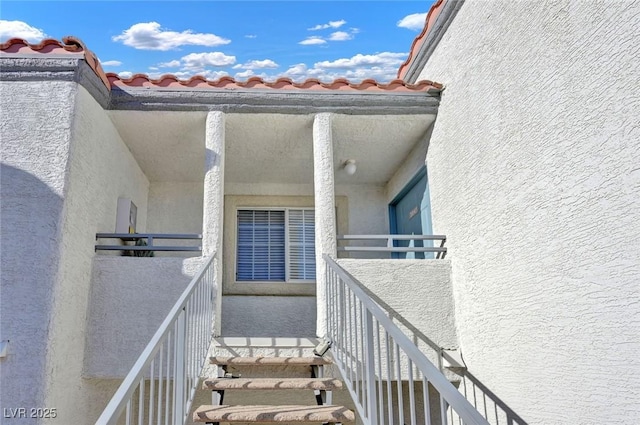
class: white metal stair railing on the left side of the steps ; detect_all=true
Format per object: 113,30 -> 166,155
96,254 -> 216,425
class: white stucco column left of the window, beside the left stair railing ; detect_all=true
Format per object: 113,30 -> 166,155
202,111 -> 225,335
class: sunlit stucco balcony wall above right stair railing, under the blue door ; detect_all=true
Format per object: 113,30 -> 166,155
337,258 -> 458,352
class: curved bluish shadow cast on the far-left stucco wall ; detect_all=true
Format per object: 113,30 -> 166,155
0,164 -> 63,418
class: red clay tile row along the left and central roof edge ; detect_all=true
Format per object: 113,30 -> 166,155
0,36 -> 442,92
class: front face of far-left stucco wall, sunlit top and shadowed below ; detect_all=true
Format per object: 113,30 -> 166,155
0,81 -> 75,425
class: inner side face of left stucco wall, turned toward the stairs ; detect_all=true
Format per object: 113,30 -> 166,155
45,87 -> 149,423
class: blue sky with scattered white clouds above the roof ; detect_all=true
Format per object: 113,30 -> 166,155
0,0 -> 432,82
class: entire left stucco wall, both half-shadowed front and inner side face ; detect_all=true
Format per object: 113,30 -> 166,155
0,82 -> 148,423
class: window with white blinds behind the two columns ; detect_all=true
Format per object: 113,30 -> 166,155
236,208 -> 316,282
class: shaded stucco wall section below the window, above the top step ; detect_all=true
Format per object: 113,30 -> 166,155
222,295 -> 316,338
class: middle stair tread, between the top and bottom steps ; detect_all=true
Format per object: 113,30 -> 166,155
202,378 -> 342,390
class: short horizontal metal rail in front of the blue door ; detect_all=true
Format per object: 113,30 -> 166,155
337,235 -> 447,259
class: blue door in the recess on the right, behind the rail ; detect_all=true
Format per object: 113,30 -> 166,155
390,168 -> 433,258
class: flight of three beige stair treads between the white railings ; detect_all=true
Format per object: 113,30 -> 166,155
193,356 -> 355,424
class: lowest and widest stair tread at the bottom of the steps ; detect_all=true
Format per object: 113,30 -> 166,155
193,405 -> 355,423
